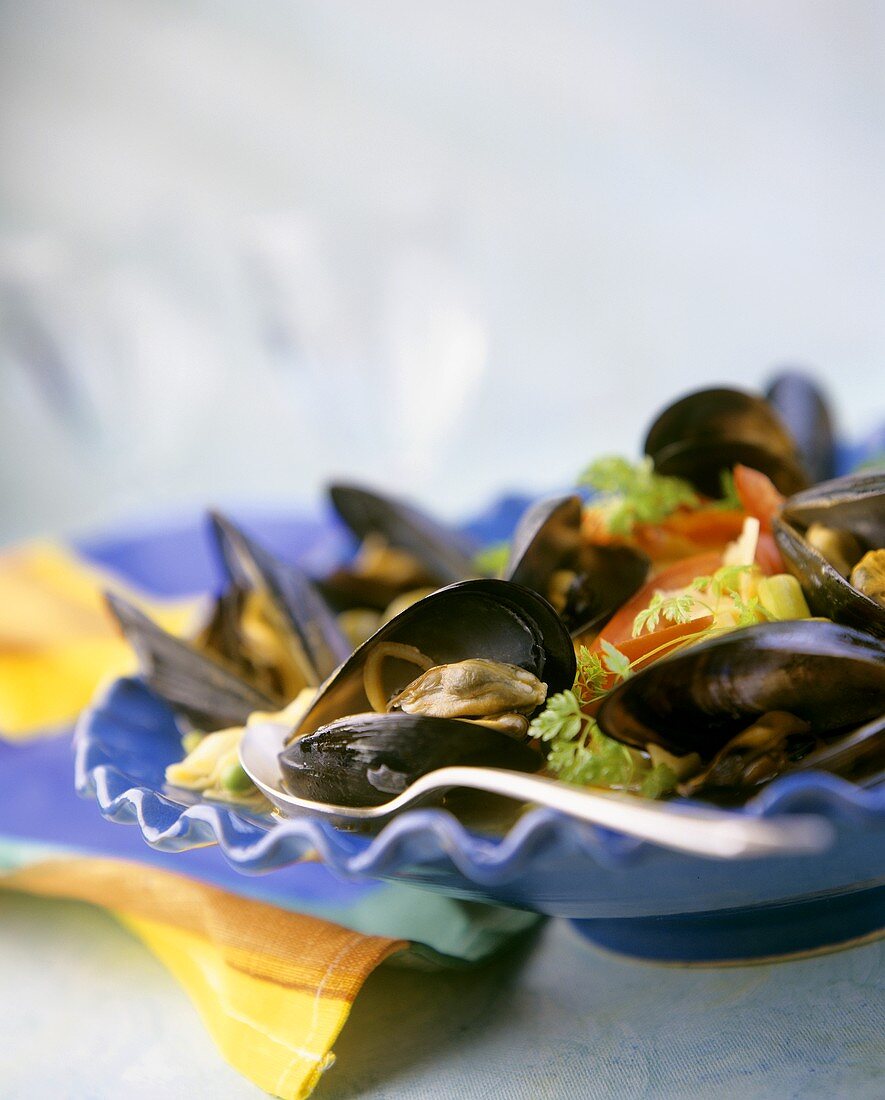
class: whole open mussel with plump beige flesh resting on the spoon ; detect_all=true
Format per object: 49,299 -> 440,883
280,580 -> 575,805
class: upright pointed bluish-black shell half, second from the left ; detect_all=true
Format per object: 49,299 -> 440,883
210,513 -> 351,686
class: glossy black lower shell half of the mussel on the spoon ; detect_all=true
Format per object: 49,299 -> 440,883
279,714 -> 544,806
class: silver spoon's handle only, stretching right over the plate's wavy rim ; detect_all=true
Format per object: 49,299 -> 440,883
408,767 -> 833,859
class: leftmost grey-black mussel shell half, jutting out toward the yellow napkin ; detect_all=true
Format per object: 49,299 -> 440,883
106,593 -> 279,730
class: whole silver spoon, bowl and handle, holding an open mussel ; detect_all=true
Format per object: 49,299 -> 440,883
240,722 -> 833,859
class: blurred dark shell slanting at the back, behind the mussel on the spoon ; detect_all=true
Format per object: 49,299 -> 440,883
329,483 -> 476,585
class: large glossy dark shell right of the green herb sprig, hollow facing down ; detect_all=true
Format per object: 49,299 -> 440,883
598,619 -> 885,760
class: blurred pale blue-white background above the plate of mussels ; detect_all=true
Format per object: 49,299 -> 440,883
0,0 -> 885,537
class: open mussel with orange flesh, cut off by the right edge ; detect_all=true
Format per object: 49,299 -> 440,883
774,470 -> 885,638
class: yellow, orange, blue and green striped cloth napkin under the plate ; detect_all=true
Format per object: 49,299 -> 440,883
0,543 -> 535,1098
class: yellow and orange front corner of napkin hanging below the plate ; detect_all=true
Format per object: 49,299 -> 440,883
0,858 -> 408,1100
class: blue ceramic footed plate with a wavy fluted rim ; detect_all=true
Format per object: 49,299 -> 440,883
76,501 -> 885,963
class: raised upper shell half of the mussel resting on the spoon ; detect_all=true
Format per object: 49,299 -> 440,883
294,580 -> 575,735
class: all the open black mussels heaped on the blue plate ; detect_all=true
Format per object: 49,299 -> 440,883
109,375 -> 885,805
